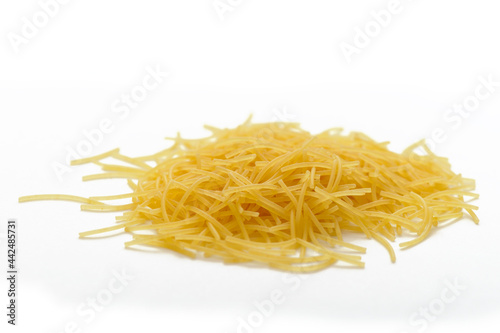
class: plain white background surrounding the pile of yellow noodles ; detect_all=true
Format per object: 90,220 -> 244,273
0,0 -> 500,333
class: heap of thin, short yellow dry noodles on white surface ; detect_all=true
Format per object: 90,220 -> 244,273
19,119 -> 479,272
